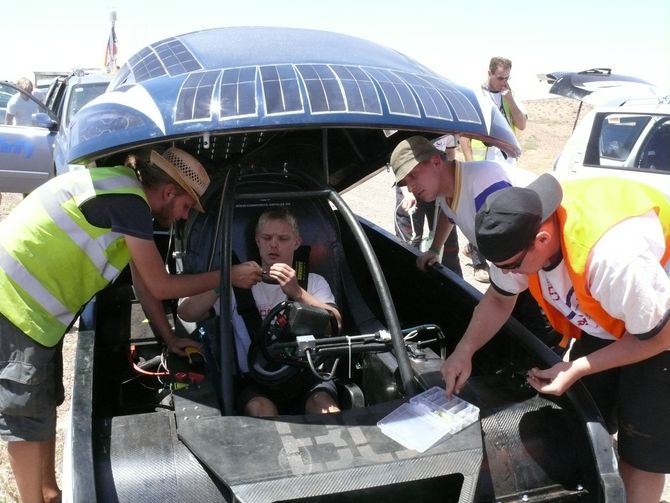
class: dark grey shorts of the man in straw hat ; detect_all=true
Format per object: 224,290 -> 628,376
0,314 -> 65,442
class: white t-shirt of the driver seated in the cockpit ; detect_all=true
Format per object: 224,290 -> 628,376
222,273 -> 335,372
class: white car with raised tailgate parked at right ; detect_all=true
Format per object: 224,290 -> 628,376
549,69 -> 670,195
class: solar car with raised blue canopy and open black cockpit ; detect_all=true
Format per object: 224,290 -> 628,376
64,27 -> 623,503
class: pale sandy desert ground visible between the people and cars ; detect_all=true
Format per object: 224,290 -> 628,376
0,98 -> 670,503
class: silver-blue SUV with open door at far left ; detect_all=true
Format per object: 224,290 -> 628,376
0,70 -> 111,194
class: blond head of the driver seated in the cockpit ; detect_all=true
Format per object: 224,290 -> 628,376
256,208 -> 301,267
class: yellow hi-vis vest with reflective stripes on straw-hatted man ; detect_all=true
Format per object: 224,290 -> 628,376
0,166 -> 147,347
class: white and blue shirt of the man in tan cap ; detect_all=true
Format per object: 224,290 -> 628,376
439,161 -> 537,243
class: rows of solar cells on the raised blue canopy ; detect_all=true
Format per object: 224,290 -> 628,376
129,38 -> 480,124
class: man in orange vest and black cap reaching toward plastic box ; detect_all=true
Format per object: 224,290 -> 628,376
442,174 -> 670,503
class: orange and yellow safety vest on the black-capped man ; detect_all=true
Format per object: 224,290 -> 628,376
528,177 -> 670,347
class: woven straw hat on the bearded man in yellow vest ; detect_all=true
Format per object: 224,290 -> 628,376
150,147 -> 209,213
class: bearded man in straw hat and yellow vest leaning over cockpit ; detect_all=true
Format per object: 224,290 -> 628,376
0,147 -> 261,502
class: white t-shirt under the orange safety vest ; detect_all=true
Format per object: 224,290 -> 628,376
490,211 -> 670,339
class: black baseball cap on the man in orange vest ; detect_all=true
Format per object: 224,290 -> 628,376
475,173 -> 563,262
